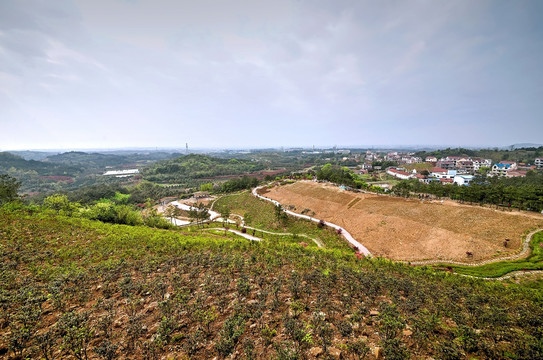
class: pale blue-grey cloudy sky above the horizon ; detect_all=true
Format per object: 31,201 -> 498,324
0,0 -> 543,150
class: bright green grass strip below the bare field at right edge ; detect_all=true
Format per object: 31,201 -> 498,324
451,231 -> 543,278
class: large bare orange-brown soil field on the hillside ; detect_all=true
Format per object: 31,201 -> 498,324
262,181 -> 543,263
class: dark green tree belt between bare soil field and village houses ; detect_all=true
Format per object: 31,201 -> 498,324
392,172 -> 543,212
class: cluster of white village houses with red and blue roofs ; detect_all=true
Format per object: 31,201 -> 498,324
385,153 -> 543,185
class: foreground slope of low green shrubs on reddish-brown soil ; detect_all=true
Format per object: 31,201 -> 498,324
0,207 -> 543,359
